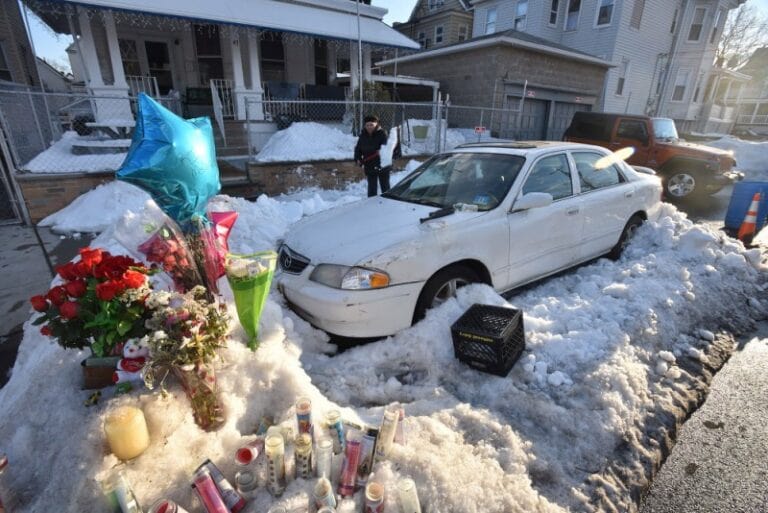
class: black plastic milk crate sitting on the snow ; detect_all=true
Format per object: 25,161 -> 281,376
451,304 -> 525,376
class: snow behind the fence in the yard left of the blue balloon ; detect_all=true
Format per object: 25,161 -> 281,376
21,131 -> 127,173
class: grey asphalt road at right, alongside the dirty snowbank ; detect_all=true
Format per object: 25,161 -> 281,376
639,188 -> 768,513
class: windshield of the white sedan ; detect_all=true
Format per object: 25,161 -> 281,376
382,153 -> 525,210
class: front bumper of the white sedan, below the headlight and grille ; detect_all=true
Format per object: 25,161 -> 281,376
276,270 -> 424,338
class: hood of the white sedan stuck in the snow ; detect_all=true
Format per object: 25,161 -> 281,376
285,196 -> 483,265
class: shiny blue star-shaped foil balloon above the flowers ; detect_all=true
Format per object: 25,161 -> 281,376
117,93 -> 221,228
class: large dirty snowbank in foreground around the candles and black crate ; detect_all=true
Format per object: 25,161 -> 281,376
0,183 -> 766,513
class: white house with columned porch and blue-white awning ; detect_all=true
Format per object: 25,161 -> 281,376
24,0 -> 419,123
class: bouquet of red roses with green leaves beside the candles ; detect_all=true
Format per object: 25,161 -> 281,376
30,248 -> 152,356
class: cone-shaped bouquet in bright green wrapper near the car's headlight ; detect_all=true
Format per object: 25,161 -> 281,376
224,251 -> 277,350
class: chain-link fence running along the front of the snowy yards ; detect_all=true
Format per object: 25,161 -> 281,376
0,89 -> 536,174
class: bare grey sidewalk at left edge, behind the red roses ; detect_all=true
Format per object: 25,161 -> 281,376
0,225 -> 91,387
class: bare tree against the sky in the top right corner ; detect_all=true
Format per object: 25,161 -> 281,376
715,4 -> 768,68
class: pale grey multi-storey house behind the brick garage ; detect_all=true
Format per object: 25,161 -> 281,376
472,0 -> 745,132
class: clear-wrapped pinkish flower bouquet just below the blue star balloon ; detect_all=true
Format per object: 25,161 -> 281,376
115,201 -> 206,292
